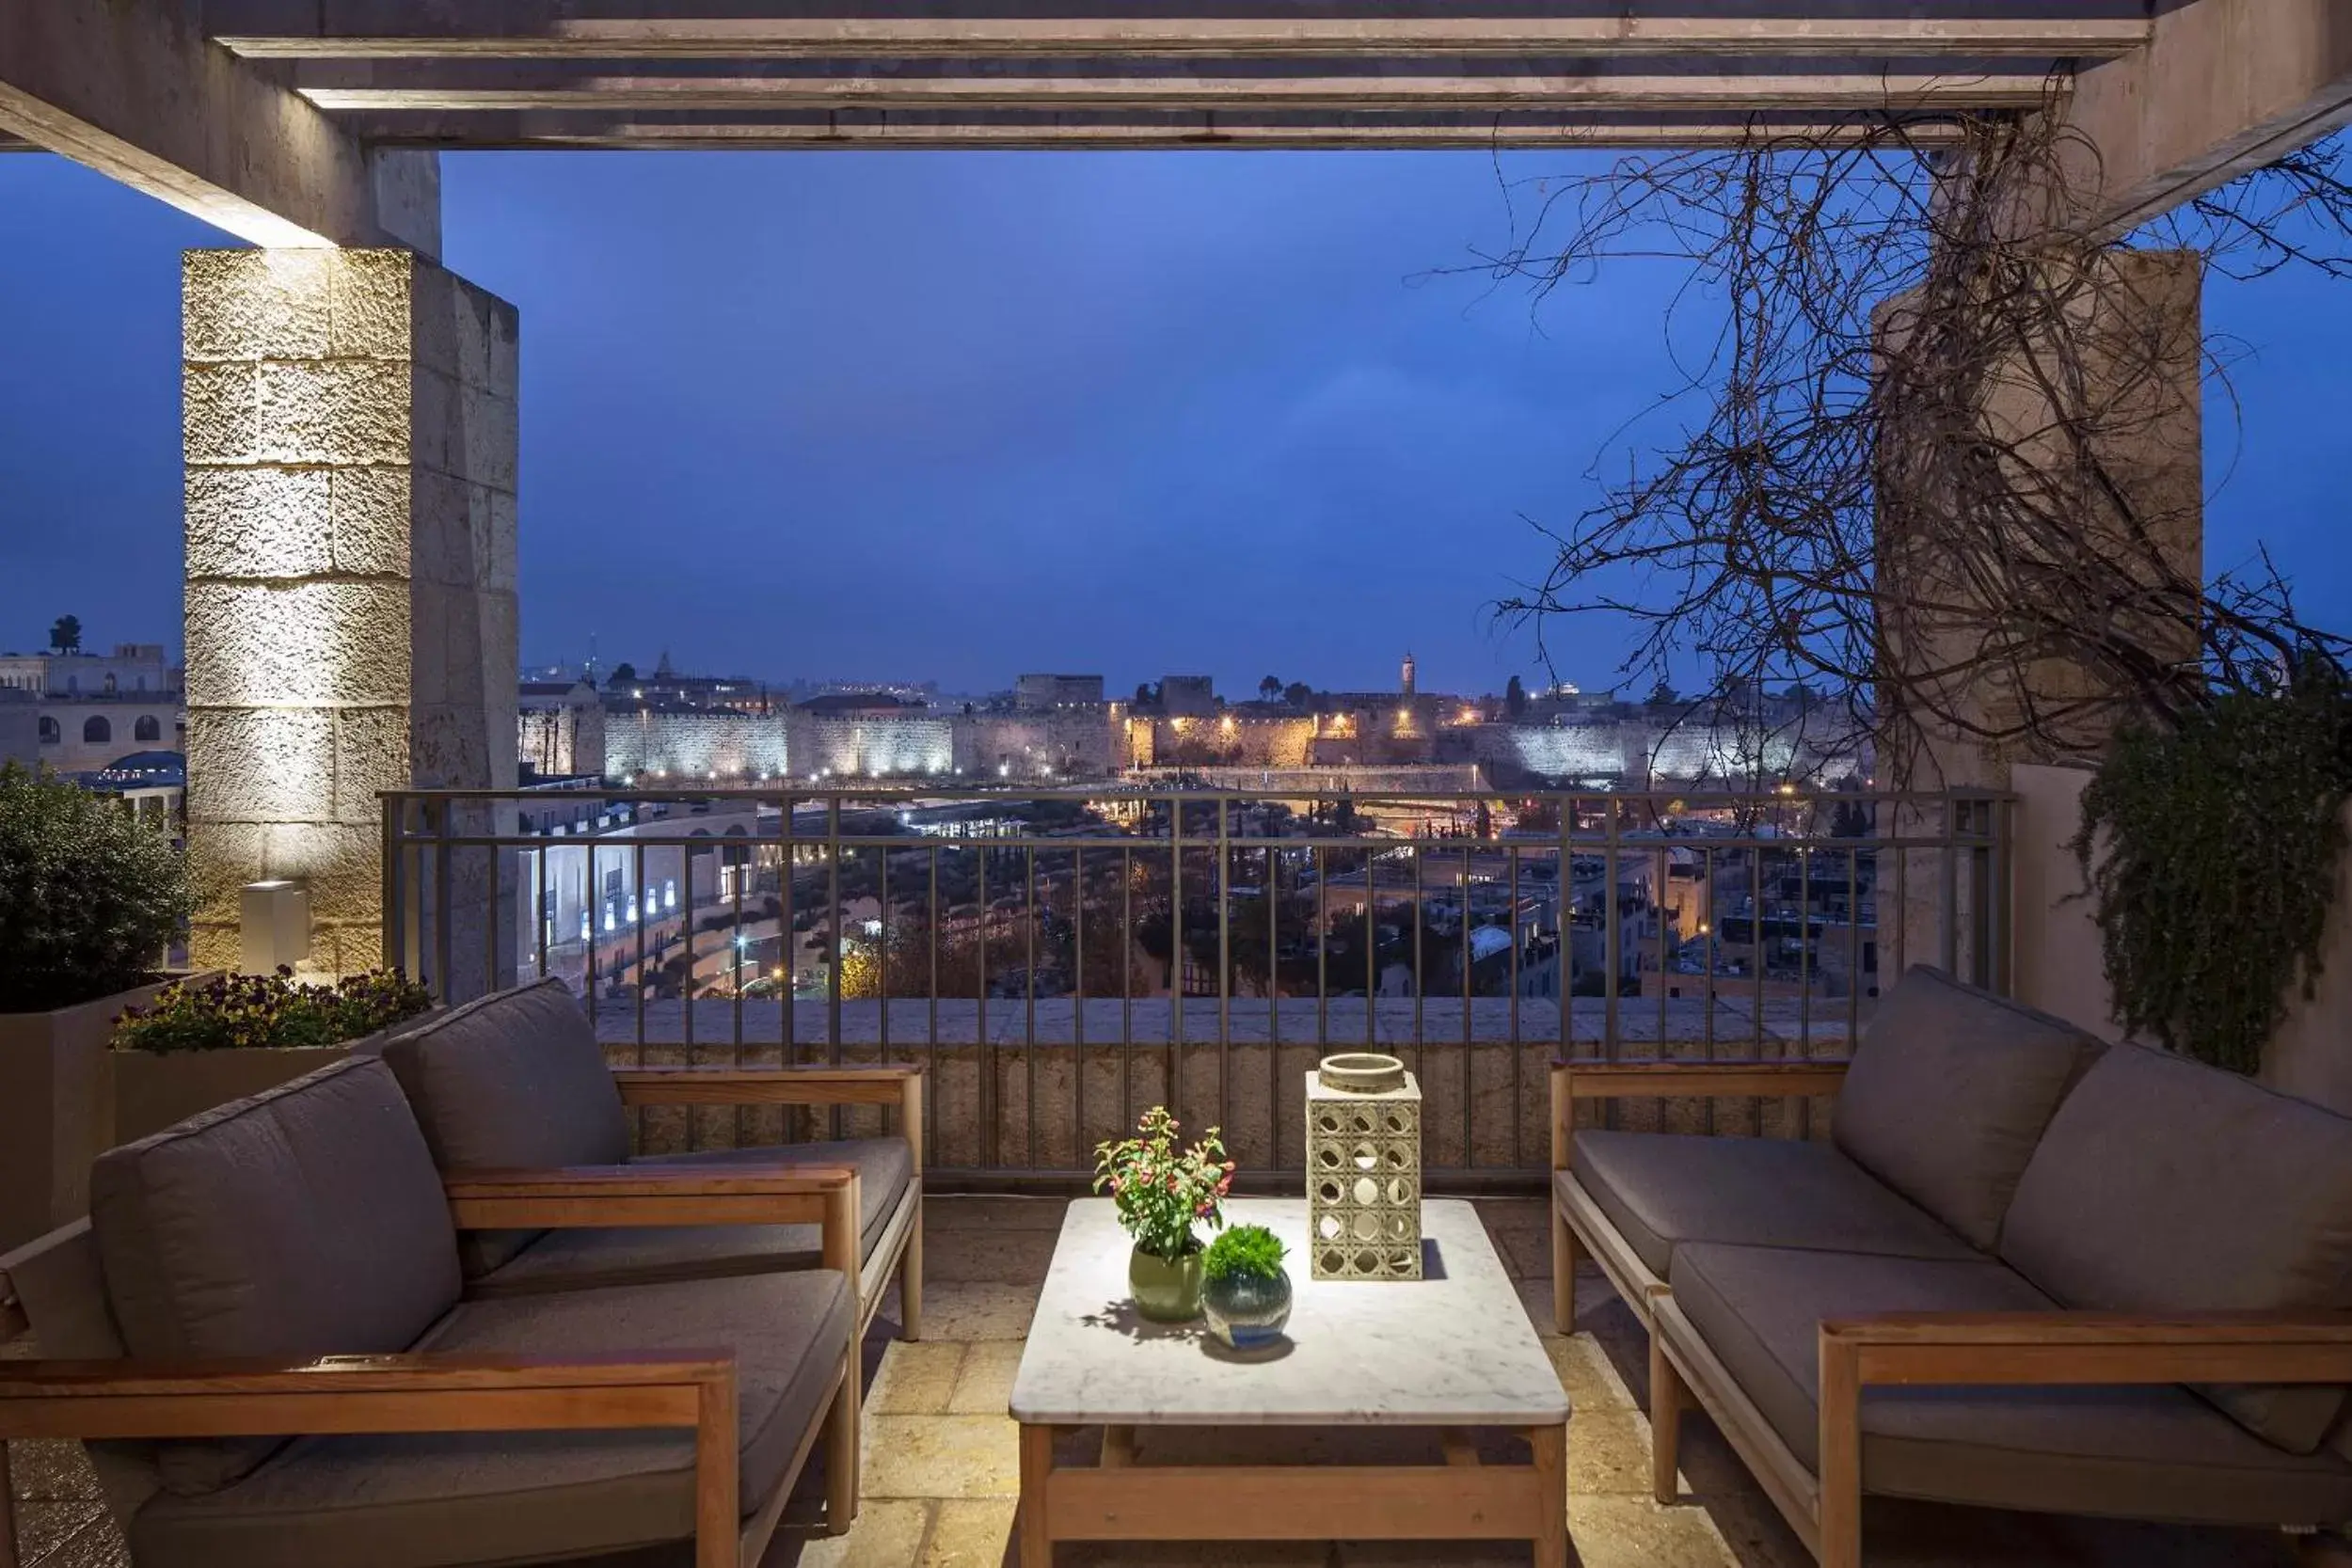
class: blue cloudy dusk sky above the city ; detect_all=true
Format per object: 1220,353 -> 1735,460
0,152 -> 2352,696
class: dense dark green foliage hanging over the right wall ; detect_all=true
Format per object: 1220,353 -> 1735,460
2073,660 -> 2352,1072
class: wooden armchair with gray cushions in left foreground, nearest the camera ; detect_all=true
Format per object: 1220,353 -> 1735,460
0,1058 -> 861,1568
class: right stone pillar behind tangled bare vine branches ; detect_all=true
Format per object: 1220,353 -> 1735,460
1880,251 -> 2204,991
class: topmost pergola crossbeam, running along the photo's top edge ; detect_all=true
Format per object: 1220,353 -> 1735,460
207,0 -> 2150,58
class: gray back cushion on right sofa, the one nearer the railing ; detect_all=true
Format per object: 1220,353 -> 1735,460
1830,964 -> 2101,1253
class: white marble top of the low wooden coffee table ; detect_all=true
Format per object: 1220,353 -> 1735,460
1011,1199 -> 1569,1427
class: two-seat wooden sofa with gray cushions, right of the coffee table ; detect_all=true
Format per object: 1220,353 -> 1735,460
1552,969 -> 2352,1568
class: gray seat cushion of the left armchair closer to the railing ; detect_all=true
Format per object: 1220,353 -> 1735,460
469,1138 -> 913,1298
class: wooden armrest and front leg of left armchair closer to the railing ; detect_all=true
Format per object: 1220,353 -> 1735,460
612,1063 -> 922,1340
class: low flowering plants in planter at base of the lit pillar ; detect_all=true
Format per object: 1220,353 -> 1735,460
113,969 -> 433,1051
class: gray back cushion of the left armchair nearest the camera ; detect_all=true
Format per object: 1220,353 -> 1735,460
89,1058 -> 459,1493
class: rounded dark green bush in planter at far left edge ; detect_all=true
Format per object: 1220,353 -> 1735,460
0,764 -> 191,1013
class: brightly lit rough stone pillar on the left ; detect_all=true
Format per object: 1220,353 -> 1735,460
182,249 -> 517,975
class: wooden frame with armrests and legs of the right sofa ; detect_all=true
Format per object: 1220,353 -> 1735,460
1550,1060 -> 2352,1568
